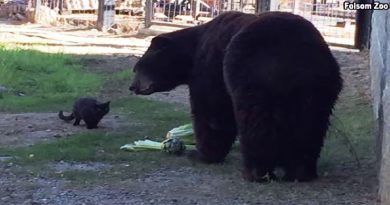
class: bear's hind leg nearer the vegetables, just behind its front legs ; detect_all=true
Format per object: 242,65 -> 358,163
235,98 -> 279,182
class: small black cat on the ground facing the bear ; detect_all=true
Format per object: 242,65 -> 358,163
58,98 -> 110,129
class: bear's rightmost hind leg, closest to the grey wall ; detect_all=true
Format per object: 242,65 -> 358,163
284,92 -> 334,181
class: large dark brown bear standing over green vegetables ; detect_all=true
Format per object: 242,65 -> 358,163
130,12 -> 342,181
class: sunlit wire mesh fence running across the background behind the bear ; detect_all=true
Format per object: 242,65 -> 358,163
0,0 -> 356,46
